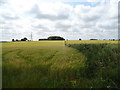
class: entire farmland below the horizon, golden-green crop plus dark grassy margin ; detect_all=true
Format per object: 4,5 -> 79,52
2,40 -> 120,88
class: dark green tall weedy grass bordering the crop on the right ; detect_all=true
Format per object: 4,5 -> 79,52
68,43 -> 120,88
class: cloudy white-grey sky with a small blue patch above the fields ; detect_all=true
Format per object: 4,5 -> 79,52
0,0 -> 118,41
